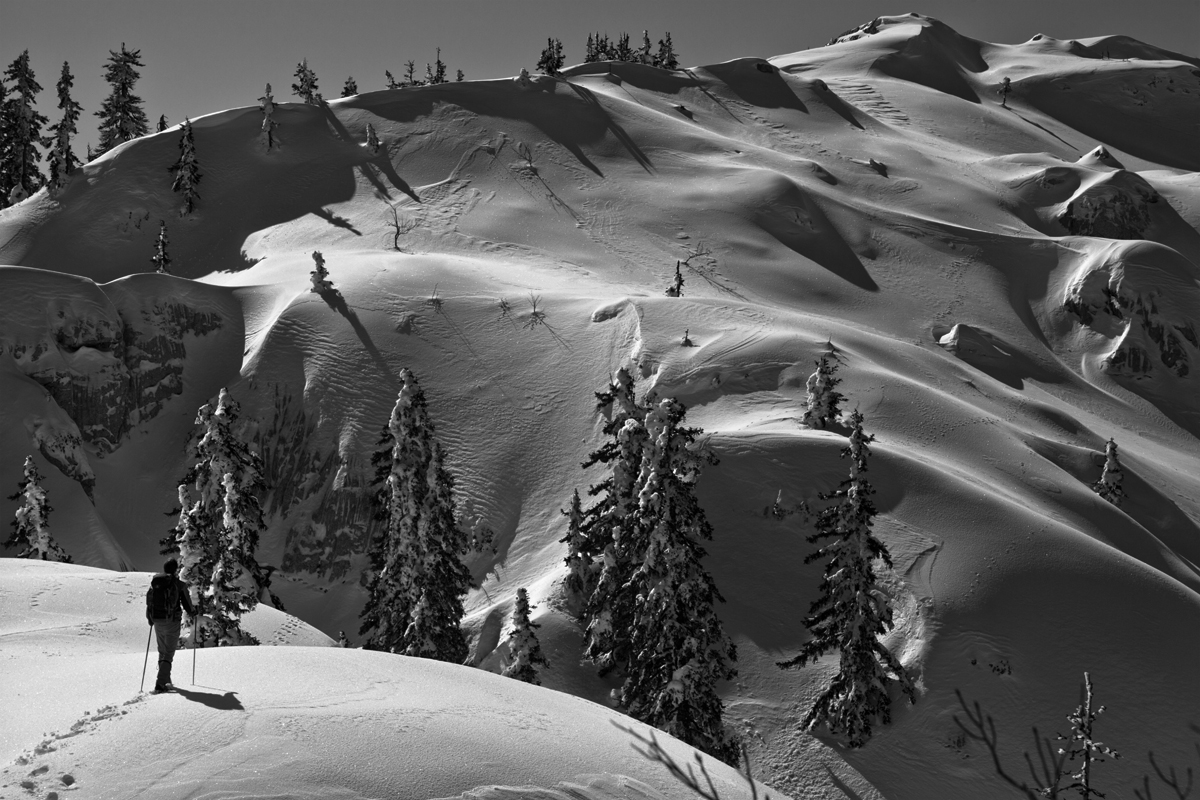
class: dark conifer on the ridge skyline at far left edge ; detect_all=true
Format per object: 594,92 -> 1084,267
0,50 -> 48,204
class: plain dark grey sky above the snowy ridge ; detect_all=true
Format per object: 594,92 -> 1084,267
7,0 -> 1200,155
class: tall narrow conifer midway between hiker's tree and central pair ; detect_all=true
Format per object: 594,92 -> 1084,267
360,369 -> 470,663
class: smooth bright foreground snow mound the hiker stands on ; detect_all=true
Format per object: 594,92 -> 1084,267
0,559 -> 786,800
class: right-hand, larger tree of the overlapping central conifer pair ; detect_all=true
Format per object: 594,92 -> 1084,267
619,399 -> 738,764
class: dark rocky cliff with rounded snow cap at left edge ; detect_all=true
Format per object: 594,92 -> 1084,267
0,267 -> 231,495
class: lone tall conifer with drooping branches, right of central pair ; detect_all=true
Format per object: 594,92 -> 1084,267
779,410 -> 916,747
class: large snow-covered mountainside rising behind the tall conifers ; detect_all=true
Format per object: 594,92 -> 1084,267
0,10 -> 1200,800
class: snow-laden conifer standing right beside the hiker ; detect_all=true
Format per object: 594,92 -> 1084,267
162,389 -> 278,646
